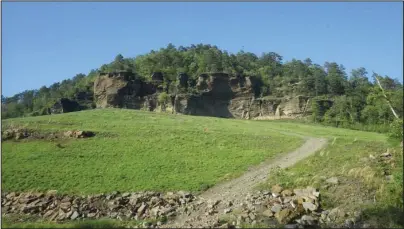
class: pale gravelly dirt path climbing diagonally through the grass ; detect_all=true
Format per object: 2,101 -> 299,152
163,138 -> 327,228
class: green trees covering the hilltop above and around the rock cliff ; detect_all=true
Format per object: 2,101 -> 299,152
2,44 -> 403,135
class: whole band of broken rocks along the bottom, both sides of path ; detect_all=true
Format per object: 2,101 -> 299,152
1,185 -> 357,228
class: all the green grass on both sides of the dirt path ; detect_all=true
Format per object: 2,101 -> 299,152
2,109 -> 403,227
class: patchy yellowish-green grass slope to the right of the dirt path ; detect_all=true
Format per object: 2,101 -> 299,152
257,122 -> 404,228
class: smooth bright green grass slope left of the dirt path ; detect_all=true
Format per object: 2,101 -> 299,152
2,109 -> 303,194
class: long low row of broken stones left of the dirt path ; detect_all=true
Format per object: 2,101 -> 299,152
1,191 -> 195,225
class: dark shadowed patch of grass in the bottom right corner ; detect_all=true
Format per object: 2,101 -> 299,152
362,206 -> 404,228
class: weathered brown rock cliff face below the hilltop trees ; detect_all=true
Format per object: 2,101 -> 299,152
94,72 -> 310,119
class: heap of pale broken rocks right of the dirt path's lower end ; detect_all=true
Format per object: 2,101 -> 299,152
178,185 -> 330,228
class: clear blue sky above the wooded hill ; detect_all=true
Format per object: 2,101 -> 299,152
2,2 -> 403,96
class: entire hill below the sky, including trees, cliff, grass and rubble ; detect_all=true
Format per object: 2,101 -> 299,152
1,44 -> 404,228
